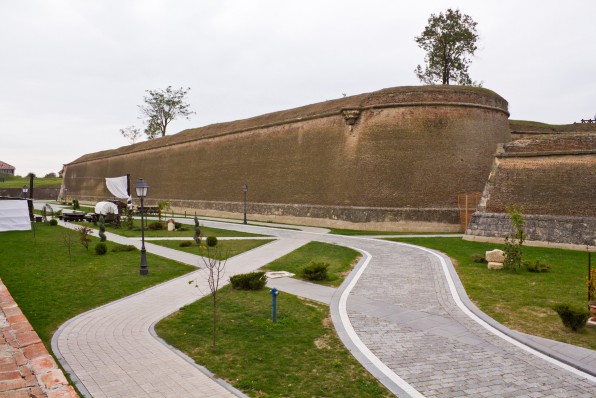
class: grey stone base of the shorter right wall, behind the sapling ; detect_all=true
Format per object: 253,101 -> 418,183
464,212 -> 596,250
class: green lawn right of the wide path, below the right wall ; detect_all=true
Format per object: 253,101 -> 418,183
389,238 -> 596,350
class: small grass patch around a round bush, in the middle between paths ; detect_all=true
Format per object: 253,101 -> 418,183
262,242 -> 360,287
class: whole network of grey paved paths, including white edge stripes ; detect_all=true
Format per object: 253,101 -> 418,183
52,219 -> 596,397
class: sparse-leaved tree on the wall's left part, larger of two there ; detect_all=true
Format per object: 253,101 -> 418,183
139,86 -> 194,139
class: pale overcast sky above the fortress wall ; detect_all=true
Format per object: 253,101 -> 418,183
0,0 -> 596,176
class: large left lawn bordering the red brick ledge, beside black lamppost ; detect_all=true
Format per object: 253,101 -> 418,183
0,223 -> 196,347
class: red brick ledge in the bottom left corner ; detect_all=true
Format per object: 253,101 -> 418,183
0,279 -> 78,398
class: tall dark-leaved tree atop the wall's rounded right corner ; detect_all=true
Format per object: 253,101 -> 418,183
414,9 -> 479,85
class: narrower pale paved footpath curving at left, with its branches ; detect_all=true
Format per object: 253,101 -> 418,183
56,225 -> 307,398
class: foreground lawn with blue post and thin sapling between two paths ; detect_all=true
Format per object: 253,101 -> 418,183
156,286 -> 393,398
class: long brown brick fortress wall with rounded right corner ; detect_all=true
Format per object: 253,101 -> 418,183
64,87 -> 509,231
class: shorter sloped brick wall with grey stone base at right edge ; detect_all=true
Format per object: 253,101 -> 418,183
466,133 -> 596,245
